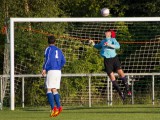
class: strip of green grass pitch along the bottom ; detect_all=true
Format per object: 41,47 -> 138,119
0,105 -> 160,120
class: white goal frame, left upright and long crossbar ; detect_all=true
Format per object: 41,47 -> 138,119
10,17 -> 160,110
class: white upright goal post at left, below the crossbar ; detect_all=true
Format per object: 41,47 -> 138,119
10,18 -> 15,110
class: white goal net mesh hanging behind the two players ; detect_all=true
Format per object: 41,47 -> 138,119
0,21 -> 160,109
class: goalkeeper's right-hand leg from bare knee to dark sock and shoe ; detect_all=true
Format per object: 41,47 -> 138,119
117,69 -> 131,96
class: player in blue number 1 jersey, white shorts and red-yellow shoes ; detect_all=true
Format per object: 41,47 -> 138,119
42,36 -> 66,117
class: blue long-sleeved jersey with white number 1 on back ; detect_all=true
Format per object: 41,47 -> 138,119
43,45 -> 66,71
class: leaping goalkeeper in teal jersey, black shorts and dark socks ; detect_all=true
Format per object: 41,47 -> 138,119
89,30 -> 131,100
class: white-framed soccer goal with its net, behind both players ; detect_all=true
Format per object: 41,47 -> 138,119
1,18 -> 160,109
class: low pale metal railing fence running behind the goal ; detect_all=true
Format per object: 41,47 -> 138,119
0,73 -> 160,109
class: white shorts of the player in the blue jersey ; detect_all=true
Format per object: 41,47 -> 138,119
45,70 -> 61,89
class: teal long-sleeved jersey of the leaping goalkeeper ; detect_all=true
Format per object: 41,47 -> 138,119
94,38 -> 120,58
